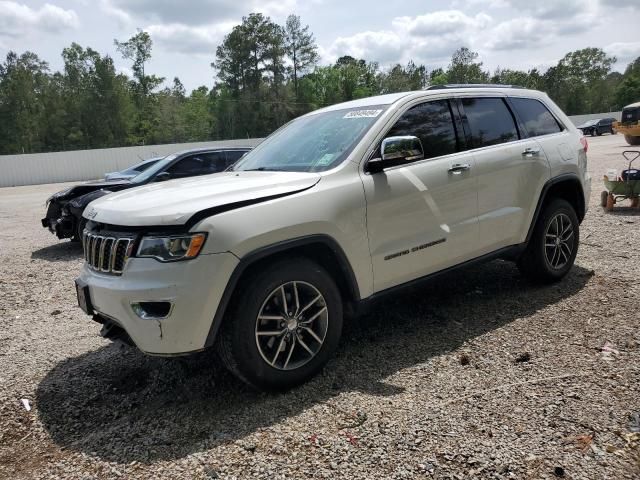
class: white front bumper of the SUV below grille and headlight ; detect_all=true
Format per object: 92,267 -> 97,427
79,253 -> 238,356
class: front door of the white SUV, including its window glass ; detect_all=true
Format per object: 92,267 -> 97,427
362,99 -> 478,291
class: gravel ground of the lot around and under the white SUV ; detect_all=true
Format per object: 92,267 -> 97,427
0,135 -> 640,479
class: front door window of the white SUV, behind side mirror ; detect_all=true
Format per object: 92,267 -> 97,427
386,100 -> 458,158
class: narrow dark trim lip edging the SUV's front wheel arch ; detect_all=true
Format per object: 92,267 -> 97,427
204,234 -> 361,348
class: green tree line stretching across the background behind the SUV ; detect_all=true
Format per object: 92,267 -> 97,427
0,13 -> 640,154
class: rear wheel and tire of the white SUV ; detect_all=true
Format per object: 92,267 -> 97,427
518,198 -> 580,283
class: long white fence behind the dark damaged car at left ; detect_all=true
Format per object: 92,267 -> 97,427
0,139 -> 260,187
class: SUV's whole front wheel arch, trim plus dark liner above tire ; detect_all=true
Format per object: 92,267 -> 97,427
205,234 -> 361,347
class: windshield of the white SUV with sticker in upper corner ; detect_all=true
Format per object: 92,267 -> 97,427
231,105 -> 387,172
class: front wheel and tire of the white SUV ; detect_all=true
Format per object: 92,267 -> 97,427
217,258 -> 342,390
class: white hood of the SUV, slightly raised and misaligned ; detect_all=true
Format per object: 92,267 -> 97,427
83,171 -> 321,227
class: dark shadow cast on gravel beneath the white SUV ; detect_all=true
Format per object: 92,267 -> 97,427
37,261 -> 592,463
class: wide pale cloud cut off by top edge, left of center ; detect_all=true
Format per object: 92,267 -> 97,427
102,0 -> 296,26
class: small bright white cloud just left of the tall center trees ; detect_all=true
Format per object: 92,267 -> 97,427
145,23 -> 234,56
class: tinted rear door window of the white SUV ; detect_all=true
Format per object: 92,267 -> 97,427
462,98 -> 518,148
